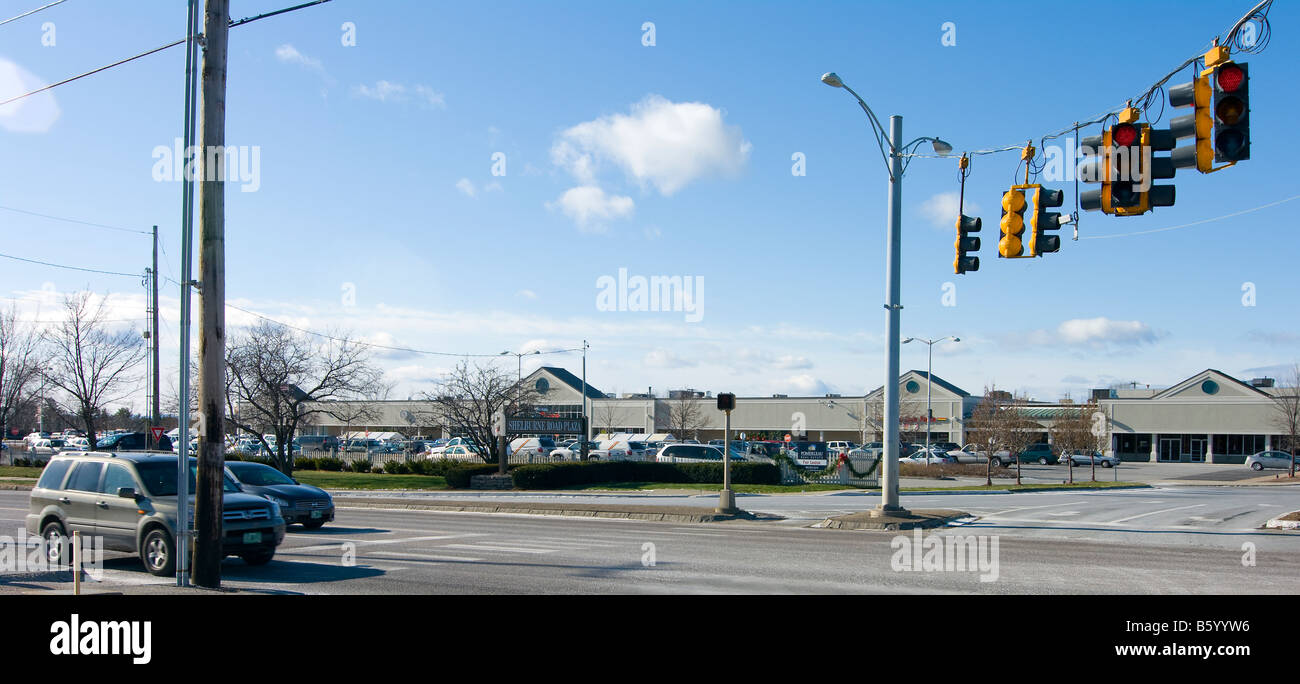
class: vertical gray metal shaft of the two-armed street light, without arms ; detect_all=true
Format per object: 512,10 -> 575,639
880,116 -> 904,511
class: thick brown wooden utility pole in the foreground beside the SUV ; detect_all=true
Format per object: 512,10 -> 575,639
191,0 -> 230,589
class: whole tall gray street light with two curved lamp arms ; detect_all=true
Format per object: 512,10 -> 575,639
822,72 -> 953,514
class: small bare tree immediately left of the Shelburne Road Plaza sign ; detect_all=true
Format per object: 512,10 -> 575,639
425,362 -> 537,463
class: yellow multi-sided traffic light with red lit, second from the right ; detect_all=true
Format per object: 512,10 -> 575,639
1079,108 -> 1177,216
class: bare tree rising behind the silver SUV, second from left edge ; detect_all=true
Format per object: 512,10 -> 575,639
42,291 -> 146,449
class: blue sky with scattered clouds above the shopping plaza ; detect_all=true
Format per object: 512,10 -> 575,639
0,0 -> 1300,401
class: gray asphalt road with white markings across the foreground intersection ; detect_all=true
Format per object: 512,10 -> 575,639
0,488 -> 1300,594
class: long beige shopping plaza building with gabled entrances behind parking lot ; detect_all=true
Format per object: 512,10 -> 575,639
303,367 -> 1296,463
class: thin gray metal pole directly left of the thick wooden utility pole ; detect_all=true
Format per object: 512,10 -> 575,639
176,0 -> 199,586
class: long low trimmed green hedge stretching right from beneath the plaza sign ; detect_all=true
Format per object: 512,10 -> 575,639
504,460 -> 781,489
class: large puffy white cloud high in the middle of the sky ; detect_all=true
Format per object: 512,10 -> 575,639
551,95 -> 753,196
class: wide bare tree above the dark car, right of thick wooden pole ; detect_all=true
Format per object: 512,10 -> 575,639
223,321 -> 382,475
